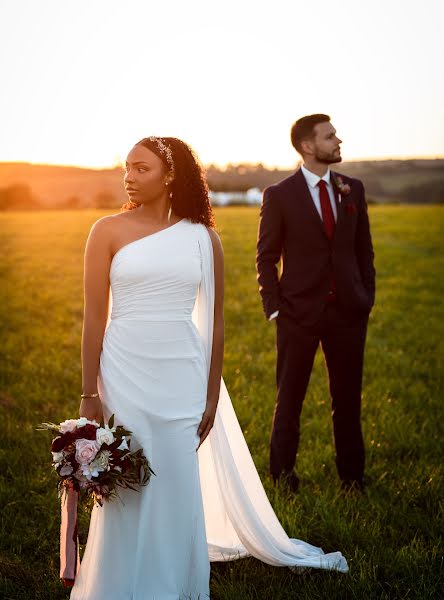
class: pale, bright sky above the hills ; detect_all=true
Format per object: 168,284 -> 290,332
0,0 -> 444,168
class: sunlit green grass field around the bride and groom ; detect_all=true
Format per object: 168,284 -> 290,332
0,206 -> 444,600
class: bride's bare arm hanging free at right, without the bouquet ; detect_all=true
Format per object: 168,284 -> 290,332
197,229 -> 224,446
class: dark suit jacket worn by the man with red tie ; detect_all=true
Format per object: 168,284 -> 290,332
256,170 -> 375,325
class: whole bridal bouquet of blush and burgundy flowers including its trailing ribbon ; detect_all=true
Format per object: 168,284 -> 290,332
38,415 -> 154,587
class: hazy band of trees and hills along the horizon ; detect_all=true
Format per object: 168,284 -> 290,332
0,160 -> 444,210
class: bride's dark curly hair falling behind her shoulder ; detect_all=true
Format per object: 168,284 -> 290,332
122,137 -> 215,227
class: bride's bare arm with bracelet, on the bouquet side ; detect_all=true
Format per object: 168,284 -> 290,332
79,217 -> 111,422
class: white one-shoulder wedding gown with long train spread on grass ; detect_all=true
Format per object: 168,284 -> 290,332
71,219 -> 348,600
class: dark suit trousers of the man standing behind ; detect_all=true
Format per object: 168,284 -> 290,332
270,302 -> 368,481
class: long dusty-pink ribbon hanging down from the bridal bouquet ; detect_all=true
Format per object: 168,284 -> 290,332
60,486 -> 80,587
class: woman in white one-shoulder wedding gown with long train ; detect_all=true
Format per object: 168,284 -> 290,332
71,137 -> 348,600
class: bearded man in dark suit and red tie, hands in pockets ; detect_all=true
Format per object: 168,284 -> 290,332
257,114 -> 375,492
